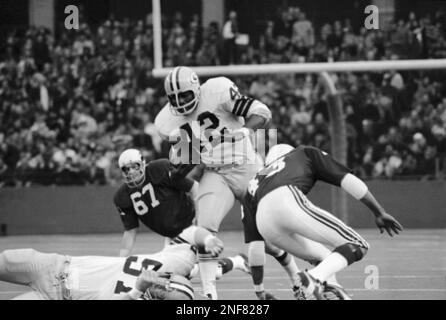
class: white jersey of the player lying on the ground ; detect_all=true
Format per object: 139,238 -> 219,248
67,244 -> 196,300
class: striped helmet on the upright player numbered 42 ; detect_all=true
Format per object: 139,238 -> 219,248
164,67 -> 200,116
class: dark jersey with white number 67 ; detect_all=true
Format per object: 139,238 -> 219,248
114,159 -> 195,237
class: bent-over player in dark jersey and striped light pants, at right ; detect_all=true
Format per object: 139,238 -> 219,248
243,145 -> 402,299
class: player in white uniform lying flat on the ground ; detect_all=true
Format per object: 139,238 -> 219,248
0,244 -> 247,300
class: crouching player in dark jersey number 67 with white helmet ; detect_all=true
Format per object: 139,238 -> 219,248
114,149 -> 249,276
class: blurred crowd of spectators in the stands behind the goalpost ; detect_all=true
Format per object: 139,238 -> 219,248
0,7 -> 446,186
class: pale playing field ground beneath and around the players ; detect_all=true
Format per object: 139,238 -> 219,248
0,229 -> 446,300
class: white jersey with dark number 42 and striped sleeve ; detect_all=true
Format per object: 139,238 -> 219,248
155,77 -> 264,167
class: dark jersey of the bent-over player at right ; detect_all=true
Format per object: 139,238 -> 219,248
242,146 -> 351,242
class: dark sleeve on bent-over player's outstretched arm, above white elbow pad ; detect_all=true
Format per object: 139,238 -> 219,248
305,147 -> 351,187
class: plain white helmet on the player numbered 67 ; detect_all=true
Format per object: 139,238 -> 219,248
118,149 -> 146,188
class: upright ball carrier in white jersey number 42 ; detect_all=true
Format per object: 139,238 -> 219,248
155,67 -> 271,299
